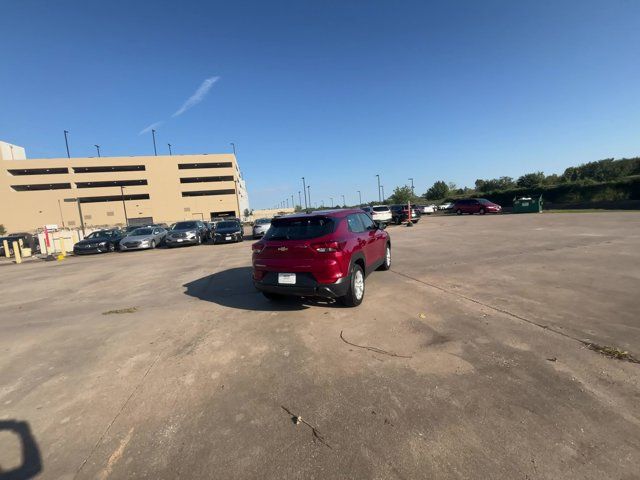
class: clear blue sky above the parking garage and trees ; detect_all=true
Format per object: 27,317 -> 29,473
0,0 -> 640,208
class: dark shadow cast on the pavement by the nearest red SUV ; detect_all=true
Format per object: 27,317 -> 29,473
183,267 -> 342,312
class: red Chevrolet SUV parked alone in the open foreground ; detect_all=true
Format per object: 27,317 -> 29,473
251,209 -> 391,307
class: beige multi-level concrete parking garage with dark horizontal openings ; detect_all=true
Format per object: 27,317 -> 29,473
0,142 -> 249,232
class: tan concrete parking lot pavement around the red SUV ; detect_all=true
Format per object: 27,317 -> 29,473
0,212 -> 640,479
